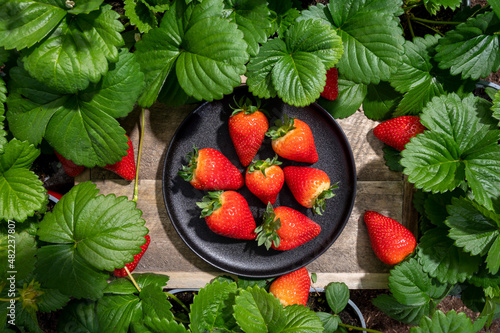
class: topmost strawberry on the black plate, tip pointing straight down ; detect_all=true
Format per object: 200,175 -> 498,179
229,98 -> 269,167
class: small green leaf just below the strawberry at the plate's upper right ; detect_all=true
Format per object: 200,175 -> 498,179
317,73 -> 368,119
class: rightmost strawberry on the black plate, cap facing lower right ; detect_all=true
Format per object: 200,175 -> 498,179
283,166 -> 338,215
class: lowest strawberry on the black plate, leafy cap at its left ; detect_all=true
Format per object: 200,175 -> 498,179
255,203 -> 321,251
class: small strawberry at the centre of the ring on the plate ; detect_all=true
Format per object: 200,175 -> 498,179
245,156 -> 285,205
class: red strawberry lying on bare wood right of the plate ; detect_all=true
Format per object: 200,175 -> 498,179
364,211 -> 417,265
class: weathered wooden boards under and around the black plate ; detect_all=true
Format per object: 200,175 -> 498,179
76,104 -> 416,289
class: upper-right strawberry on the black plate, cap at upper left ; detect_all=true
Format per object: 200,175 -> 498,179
266,115 -> 318,163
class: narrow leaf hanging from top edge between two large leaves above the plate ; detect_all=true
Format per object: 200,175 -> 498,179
225,0 -> 271,56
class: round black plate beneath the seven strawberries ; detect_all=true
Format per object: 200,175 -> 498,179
163,88 -> 356,278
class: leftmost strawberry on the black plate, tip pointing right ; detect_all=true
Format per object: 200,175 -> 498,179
178,147 -> 245,191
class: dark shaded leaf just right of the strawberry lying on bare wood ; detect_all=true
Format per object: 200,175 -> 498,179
418,227 -> 482,284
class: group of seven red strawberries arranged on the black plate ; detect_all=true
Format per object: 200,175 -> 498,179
178,98 -> 338,251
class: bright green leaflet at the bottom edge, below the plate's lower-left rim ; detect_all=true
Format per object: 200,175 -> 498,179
190,281 -> 237,333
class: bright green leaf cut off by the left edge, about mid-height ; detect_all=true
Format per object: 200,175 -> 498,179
0,139 -> 48,222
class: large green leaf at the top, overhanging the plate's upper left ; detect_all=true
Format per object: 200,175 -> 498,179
135,0 -> 248,107
